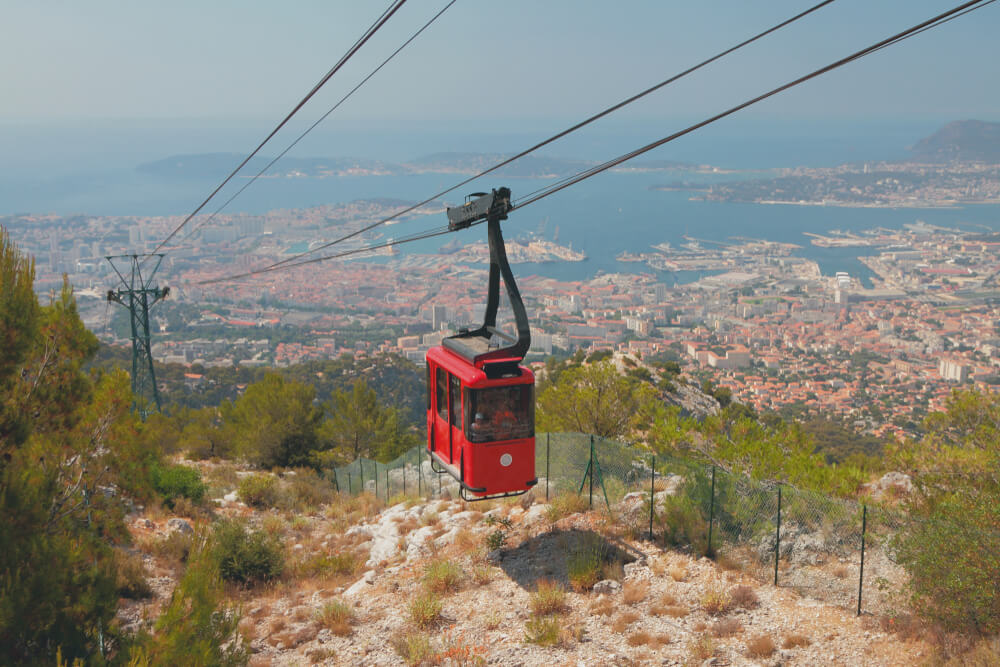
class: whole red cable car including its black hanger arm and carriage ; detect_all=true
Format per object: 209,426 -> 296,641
426,188 -> 538,501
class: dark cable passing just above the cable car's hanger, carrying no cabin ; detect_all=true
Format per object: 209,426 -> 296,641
262,0 -> 834,270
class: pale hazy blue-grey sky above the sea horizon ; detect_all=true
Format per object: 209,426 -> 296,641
0,0 -> 1000,126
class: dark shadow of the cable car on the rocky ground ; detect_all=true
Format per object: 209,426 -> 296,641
500,529 -> 642,591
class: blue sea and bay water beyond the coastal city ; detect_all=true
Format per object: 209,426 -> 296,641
0,118 -> 1000,284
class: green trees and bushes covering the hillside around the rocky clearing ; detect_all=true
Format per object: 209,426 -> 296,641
0,228 -> 1000,665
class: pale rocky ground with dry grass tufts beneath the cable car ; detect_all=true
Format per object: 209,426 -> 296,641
121,464 -> 932,665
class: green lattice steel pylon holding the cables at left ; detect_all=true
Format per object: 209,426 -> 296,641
105,255 -> 170,421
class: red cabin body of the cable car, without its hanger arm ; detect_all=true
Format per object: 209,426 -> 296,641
427,346 -> 538,500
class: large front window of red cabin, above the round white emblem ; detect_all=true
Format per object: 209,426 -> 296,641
465,384 -> 535,442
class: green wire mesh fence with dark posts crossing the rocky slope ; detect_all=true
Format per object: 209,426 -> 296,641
329,433 -> 906,614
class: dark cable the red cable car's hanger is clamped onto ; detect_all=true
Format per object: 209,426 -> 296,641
196,0 -> 996,285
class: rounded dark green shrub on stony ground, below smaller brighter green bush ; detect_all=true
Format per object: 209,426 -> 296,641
214,520 -> 285,585
